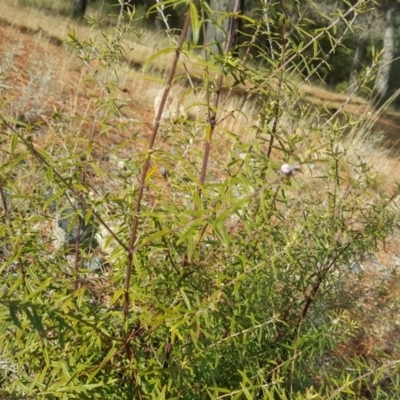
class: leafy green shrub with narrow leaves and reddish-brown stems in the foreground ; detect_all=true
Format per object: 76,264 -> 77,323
0,2 -> 399,400
